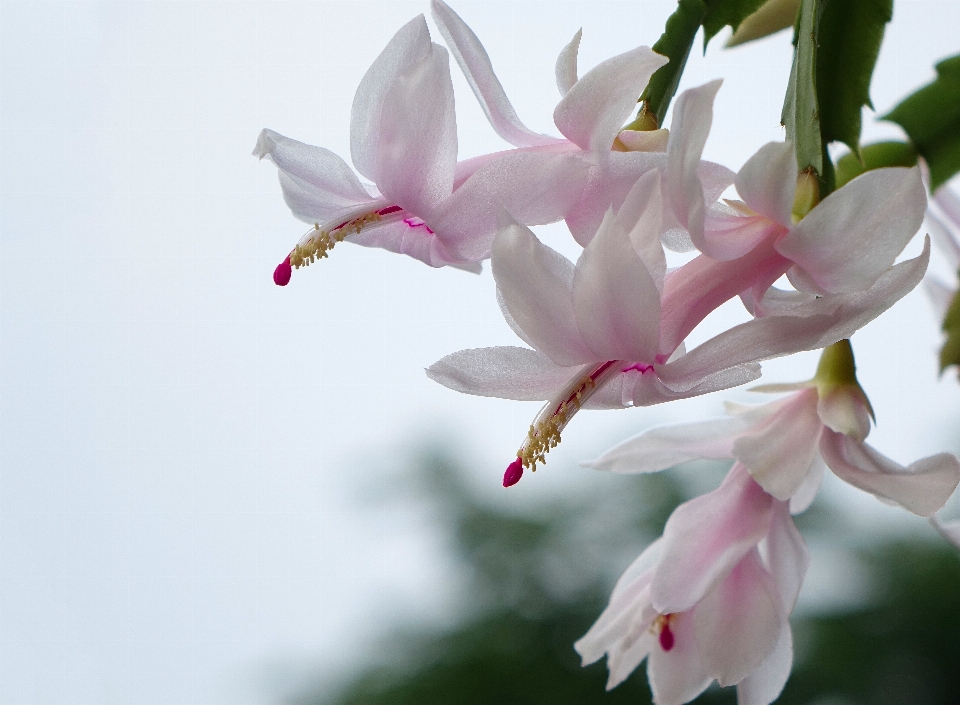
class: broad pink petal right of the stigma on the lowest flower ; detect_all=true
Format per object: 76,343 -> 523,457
694,548 -> 783,686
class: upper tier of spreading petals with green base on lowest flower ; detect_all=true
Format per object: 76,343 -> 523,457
587,341 -> 960,516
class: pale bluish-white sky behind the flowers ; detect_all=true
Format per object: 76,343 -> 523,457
0,0 -> 960,704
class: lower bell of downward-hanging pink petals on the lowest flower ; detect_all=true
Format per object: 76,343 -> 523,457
574,463 -> 809,705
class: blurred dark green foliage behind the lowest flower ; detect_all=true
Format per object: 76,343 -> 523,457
291,456 -> 960,705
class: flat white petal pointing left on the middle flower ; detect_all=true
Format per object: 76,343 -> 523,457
426,347 -> 577,401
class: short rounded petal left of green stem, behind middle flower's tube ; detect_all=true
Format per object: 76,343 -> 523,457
736,142 -> 797,228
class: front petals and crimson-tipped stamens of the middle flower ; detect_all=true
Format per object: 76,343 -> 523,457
427,157 -> 929,486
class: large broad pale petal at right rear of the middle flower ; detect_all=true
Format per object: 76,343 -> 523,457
777,167 -> 927,293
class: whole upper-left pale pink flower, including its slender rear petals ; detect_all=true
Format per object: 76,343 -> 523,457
254,2 -> 688,284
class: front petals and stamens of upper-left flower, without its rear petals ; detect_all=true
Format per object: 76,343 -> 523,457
254,15 -> 587,285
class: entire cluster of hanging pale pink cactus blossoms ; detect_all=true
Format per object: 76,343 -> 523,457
254,0 -> 960,705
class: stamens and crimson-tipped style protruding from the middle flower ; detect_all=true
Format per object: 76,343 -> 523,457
503,360 -> 622,478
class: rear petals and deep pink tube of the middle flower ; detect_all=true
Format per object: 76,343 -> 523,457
660,81 -> 926,353
